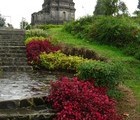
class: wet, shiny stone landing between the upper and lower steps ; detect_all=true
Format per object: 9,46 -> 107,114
0,72 -> 68,101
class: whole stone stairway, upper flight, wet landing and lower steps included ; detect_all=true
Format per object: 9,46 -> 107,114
0,30 -> 58,120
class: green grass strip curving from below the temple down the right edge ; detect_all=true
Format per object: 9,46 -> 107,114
49,28 -> 140,111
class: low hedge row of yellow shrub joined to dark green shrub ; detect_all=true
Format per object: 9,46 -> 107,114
40,52 -> 122,88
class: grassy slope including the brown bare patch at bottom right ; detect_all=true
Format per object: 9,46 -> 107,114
48,27 -> 140,120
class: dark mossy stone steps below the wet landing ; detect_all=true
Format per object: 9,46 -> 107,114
0,97 -> 54,120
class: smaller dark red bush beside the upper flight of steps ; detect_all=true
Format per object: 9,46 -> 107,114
26,40 -> 60,64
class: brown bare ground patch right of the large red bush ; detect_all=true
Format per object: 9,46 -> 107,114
118,85 -> 140,120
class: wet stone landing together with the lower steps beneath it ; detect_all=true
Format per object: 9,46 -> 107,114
0,71 -> 73,120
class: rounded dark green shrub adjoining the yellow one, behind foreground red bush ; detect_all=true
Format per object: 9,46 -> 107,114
77,61 -> 122,88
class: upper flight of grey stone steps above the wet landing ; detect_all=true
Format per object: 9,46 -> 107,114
0,30 -> 32,72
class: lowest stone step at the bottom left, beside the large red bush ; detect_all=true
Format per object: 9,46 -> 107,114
0,107 -> 55,120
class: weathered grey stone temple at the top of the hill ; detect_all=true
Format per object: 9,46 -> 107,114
31,0 -> 75,25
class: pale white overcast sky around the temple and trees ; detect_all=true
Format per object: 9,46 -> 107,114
0,0 -> 138,28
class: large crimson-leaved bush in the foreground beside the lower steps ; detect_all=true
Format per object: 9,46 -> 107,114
45,77 -> 121,120
